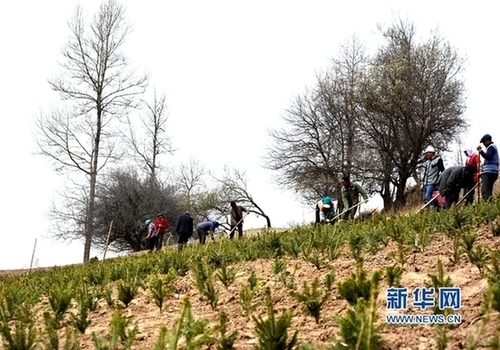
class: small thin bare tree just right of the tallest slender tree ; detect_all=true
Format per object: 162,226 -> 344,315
128,90 -> 174,181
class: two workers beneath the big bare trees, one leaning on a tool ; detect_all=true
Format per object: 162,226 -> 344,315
315,175 -> 368,223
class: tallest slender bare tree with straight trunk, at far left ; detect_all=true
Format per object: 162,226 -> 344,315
36,0 -> 148,262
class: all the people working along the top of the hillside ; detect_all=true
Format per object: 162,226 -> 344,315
144,134 -> 499,237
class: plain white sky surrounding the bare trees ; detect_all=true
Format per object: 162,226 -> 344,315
0,0 -> 500,269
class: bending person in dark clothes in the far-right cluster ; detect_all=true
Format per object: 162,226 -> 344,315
438,165 -> 476,209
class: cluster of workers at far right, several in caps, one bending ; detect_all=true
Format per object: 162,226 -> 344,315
423,134 -> 499,209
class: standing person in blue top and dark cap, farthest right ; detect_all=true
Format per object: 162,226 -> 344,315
477,134 -> 498,201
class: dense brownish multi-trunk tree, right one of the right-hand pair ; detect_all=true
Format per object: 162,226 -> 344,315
361,21 -> 467,209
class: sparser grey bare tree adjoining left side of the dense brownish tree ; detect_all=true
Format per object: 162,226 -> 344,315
266,37 -> 369,208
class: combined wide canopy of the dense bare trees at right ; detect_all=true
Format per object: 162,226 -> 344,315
266,20 -> 467,209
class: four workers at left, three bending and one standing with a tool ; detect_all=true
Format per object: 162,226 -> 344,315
144,201 -> 249,251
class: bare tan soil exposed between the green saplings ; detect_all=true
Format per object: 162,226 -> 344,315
0,224 -> 500,350
